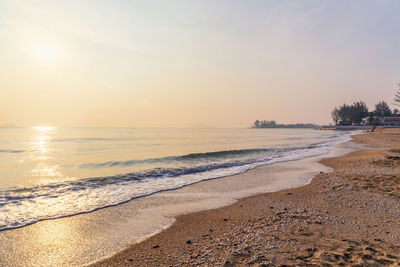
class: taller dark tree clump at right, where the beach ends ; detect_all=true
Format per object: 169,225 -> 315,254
331,101 -> 400,126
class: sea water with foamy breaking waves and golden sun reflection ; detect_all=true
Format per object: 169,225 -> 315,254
0,127 -> 353,230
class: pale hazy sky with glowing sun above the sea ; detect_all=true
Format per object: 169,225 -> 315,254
0,0 -> 400,127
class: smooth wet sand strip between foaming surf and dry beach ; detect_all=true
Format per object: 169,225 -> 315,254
0,131 -> 359,266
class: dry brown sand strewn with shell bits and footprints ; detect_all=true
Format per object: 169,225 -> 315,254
95,129 -> 400,266
